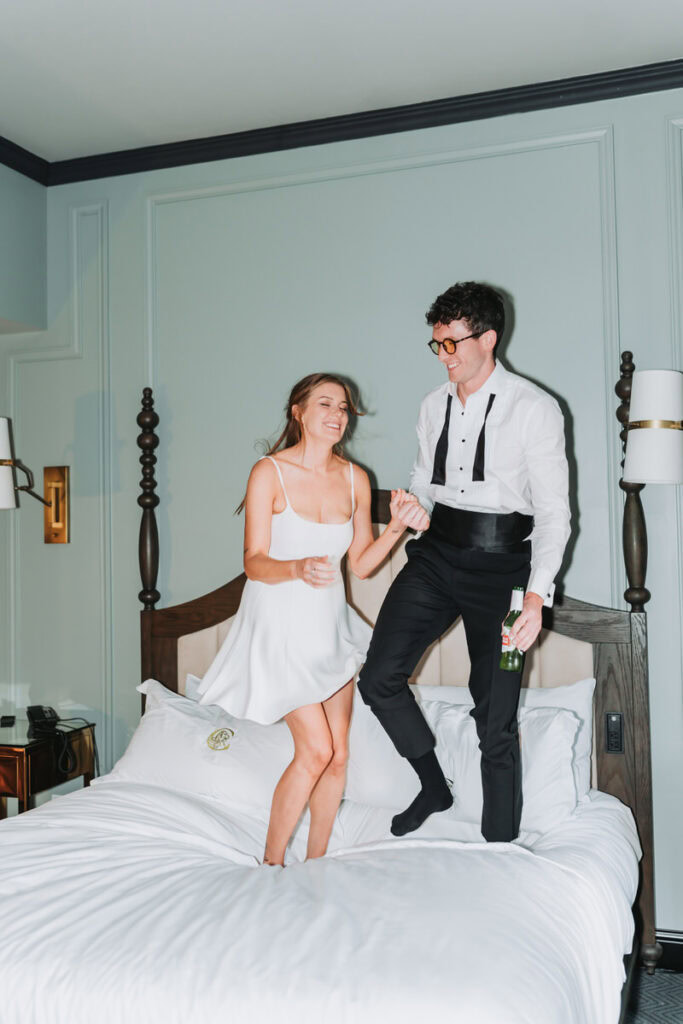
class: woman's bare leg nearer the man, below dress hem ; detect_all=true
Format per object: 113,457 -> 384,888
306,680 -> 353,859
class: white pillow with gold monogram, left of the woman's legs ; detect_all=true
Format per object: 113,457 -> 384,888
109,679 -> 294,816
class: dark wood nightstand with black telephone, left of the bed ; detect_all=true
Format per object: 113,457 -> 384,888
0,722 -> 95,818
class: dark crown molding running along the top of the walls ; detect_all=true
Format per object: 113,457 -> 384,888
0,60 -> 683,185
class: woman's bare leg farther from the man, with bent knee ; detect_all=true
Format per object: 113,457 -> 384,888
263,703 -> 333,864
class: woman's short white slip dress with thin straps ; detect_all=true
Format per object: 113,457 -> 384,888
194,456 -> 372,725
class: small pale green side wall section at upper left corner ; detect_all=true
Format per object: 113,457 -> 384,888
0,164 -> 47,334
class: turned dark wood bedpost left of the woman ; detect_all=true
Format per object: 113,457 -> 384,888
137,387 -> 161,611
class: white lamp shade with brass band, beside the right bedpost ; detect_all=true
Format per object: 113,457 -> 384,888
624,370 -> 683,483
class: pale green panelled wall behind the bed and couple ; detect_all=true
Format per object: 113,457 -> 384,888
0,91 -> 683,930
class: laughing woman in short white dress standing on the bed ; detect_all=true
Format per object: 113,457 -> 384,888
200,374 -> 419,864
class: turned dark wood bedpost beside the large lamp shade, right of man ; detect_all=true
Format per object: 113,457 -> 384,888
614,352 -> 651,611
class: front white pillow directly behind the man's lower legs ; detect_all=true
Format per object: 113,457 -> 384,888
430,701 -> 580,833
